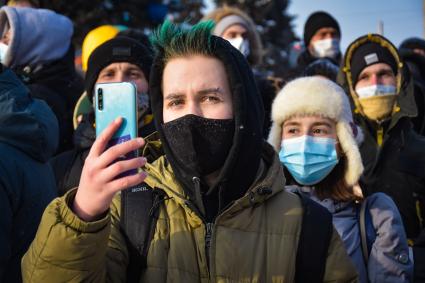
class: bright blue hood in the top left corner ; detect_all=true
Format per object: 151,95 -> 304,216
0,6 -> 73,67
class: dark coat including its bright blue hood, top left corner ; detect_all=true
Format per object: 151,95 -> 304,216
0,6 -> 83,153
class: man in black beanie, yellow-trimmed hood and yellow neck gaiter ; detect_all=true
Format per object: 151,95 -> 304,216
338,34 -> 425,282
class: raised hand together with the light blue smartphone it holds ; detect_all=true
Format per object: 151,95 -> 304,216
73,82 -> 146,221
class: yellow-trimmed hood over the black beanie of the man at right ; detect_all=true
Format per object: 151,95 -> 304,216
337,34 -> 417,128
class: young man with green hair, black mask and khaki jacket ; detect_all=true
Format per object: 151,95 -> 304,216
23,22 -> 357,282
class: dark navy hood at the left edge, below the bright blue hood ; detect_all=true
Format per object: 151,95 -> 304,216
0,70 -> 59,162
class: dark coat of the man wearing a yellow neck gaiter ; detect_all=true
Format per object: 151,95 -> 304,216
338,38 -> 425,244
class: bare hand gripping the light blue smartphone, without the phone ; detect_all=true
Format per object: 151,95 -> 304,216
72,118 -> 147,221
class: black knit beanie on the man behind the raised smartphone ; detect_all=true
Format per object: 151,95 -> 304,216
84,36 -> 153,101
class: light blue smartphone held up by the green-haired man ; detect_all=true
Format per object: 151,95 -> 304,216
94,82 -> 138,177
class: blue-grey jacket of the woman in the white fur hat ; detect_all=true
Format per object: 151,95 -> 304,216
286,186 -> 413,283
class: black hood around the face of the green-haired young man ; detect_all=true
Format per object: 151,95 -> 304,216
149,36 -> 264,217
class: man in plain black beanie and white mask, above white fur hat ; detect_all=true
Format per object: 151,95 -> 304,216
298,11 -> 341,71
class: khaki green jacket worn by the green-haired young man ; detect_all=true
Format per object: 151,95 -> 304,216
22,146 -> 357,283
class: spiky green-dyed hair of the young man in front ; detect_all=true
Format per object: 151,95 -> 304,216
150,20 -> 214,64
